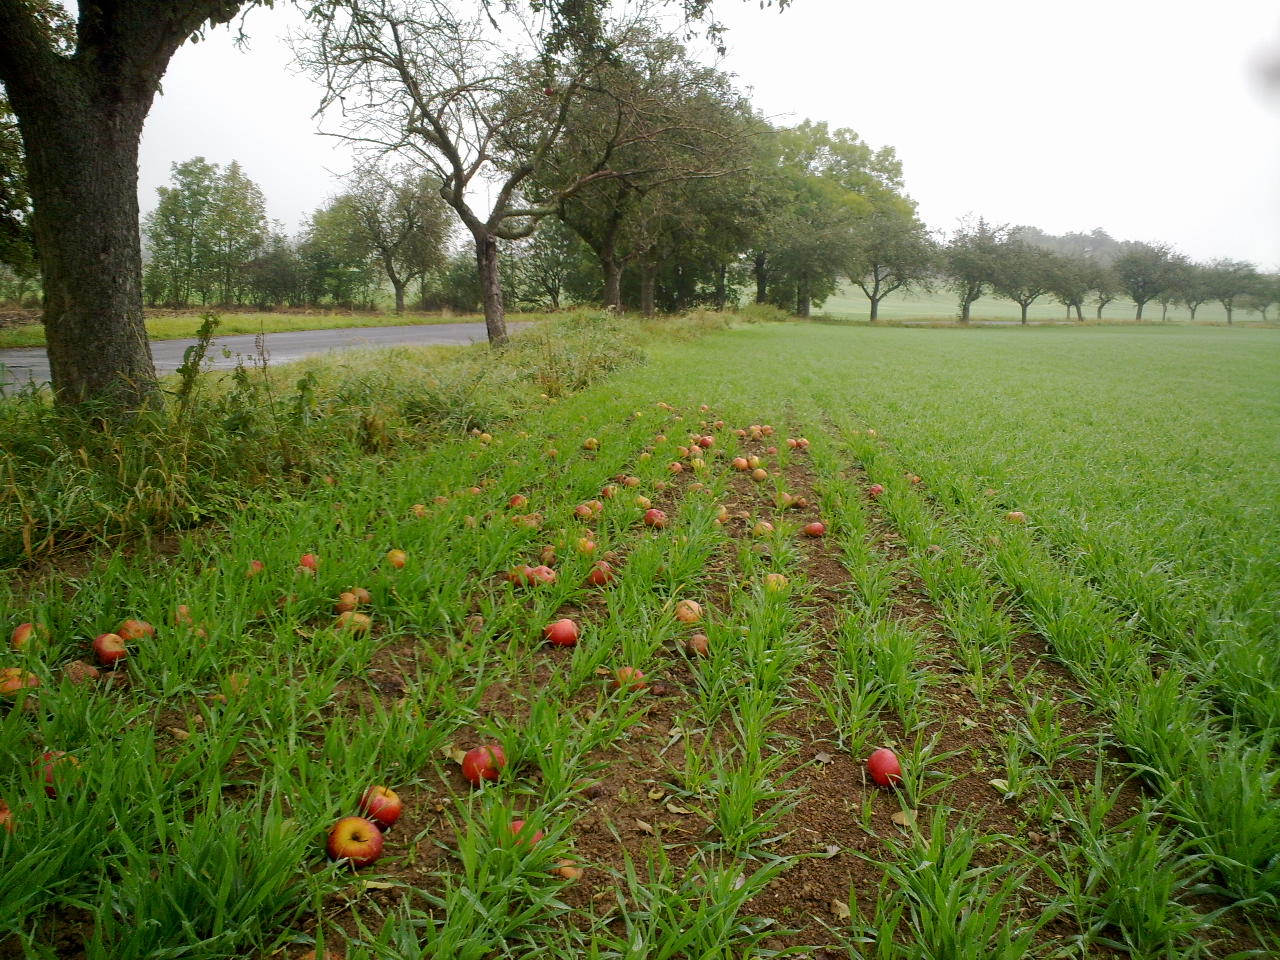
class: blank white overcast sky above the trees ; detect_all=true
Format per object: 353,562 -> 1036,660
140,0 -> 1280,270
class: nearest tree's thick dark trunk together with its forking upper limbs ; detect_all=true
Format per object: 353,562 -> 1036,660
0,0 -> 252,411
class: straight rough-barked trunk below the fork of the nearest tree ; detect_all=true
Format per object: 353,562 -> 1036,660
23,90 -> 156,408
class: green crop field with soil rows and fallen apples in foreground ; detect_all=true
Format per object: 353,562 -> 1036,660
0,324 -> 1280,960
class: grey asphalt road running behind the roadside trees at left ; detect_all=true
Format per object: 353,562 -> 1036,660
0,323 -> 527,388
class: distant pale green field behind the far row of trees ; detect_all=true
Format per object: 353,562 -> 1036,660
814,284 -> 1276,325
